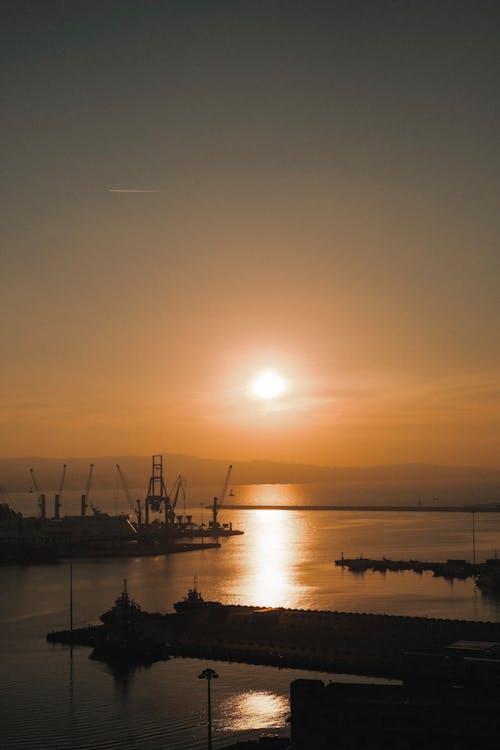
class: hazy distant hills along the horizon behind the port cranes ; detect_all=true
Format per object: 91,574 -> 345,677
0,453 -> 500,494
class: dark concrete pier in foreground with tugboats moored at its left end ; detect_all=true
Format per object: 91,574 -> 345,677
48,605 -> 500,679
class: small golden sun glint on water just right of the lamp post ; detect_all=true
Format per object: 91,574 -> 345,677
216,690 -> 290,732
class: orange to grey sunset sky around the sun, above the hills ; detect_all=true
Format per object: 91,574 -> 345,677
0,0 -> 500,467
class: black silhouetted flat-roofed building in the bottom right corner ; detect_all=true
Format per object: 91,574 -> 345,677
290,680 -> 500,750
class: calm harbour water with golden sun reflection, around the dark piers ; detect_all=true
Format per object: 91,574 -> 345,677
0,484 -> 500,750
